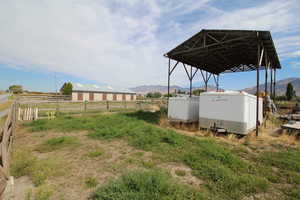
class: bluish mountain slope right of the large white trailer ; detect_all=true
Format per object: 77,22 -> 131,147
244,77 -> 300,96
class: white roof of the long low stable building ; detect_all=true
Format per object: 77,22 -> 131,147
72,83 -> 135,94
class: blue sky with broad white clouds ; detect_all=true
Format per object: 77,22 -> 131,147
0,0 -> 300,91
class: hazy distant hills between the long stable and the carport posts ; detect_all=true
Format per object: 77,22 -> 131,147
129,85 -> 220,94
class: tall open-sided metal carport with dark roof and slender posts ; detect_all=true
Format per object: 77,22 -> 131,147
164,29 -> 281,135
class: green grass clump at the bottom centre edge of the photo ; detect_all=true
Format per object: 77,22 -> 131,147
90,171 -> 204,200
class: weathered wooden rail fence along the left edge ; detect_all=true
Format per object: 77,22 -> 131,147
0,103 -> 17,200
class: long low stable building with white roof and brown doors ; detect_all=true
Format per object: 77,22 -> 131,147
72,83 -> 136,102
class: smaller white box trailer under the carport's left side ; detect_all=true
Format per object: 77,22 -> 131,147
168,97 -> 199,122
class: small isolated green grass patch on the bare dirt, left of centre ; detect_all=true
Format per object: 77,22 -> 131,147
35,136 -> 80,152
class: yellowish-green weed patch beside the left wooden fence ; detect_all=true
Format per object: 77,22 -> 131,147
11,149 -> 62,186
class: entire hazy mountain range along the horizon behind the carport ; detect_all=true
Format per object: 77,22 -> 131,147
130,77 -> 300,96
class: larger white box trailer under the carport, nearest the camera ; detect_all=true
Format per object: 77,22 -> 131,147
199,91 -> 263,135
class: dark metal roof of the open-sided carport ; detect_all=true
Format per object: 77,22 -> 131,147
165,29 -> 281,74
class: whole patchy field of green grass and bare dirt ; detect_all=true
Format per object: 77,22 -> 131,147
11,111 -> 300,200
